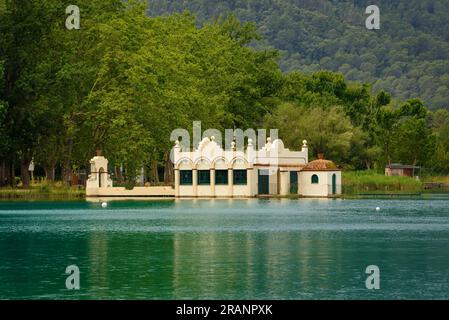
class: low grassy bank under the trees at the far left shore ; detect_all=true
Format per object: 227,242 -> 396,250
0,182 -> 86,199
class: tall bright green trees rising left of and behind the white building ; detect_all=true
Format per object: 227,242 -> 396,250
0,0 -> 282,186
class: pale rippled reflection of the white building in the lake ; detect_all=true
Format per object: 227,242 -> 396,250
173,199 -> 344,299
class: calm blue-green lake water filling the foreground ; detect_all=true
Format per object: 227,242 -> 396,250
0,196 -> 449,299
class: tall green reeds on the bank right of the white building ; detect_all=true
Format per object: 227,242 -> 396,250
342,171 -> 424,194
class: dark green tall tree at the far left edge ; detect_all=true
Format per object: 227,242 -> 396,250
0,0 -> 65,186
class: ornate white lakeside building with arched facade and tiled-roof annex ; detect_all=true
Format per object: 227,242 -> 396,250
174,137 -> 341,197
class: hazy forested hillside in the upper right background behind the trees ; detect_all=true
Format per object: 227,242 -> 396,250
148,0 -> 449,110
